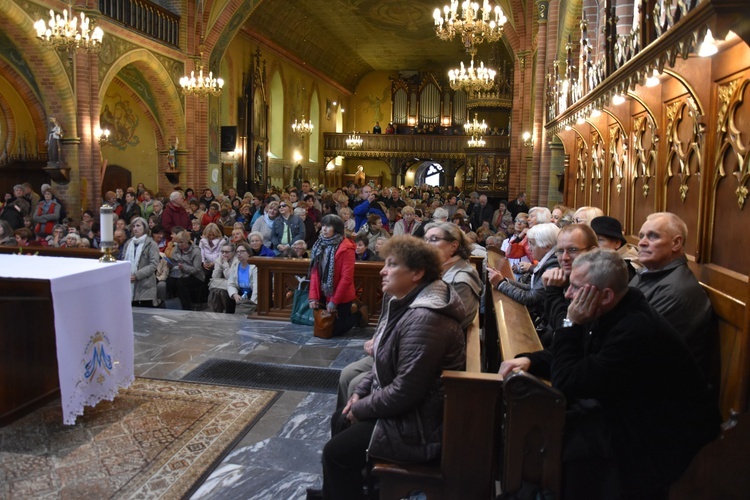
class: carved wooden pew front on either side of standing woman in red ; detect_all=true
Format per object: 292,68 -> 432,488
250,257 -> 383,325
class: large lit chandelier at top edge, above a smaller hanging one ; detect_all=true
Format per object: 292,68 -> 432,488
433,0 -> 508,54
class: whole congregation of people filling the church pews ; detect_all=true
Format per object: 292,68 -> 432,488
0,180 -> 719,498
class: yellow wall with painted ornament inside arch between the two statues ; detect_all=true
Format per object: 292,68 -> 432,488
101,91 -> 159,189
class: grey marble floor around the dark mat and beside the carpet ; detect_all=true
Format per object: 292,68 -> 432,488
133,308 -> 374,499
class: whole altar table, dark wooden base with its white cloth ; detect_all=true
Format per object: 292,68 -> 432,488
0,255 -> 134,425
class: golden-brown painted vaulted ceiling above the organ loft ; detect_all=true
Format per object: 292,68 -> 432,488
245,0 -> 511,90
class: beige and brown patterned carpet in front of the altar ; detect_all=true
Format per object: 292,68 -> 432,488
0,378 -> 280,499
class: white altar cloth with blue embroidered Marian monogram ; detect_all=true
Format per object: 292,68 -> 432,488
0,255 -> 134,425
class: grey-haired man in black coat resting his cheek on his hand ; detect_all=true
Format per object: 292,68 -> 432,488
500,250 -> 721,498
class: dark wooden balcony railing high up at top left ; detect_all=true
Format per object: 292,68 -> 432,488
99,0 -> 180,47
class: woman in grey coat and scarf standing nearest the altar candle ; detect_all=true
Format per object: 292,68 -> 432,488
122,217 -> 159,307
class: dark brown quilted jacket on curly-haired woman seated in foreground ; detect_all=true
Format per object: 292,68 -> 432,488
352,280 -> 466,462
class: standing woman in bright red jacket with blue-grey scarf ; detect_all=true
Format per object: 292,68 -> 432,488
309,215 -> 369,337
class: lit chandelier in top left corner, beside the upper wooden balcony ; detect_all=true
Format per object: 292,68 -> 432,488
34,4 -> 104,52
